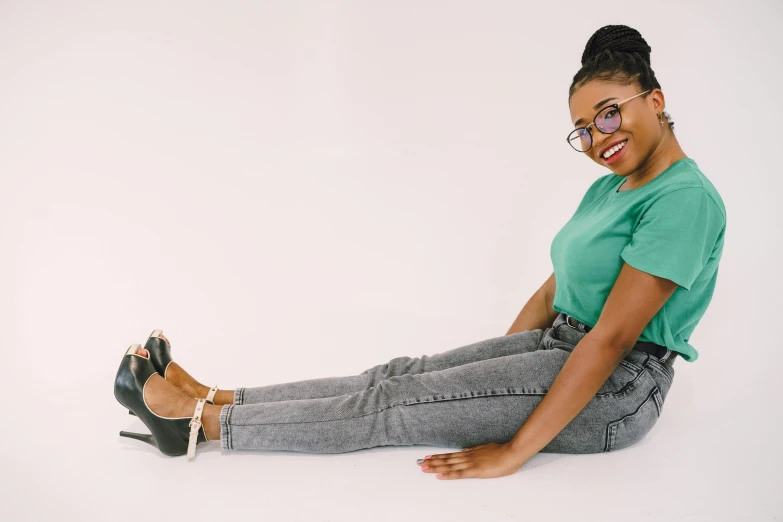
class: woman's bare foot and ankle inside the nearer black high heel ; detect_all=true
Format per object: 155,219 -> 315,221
136,348 -> 221,440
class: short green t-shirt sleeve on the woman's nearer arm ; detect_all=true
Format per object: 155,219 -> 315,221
620,187 -> 725,290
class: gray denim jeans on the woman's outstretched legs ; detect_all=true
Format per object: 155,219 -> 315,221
220,314 -> 674,453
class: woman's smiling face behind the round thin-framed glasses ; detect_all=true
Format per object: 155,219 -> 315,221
569,80 -> 664,176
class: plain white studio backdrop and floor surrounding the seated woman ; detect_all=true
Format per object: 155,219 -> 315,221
0,0 -> 783,522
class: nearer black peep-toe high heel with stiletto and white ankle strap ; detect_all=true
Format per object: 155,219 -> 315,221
114,344 -> 209,459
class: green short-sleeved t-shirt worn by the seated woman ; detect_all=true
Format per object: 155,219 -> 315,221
550,158 -> 726,362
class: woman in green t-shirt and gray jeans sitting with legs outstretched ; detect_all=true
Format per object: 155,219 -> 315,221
115,26 -> 726,479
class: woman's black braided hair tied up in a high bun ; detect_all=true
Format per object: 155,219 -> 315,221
568,25 -> 674,133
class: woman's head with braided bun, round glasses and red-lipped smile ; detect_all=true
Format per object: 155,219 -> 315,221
567,25 -> 686,190
